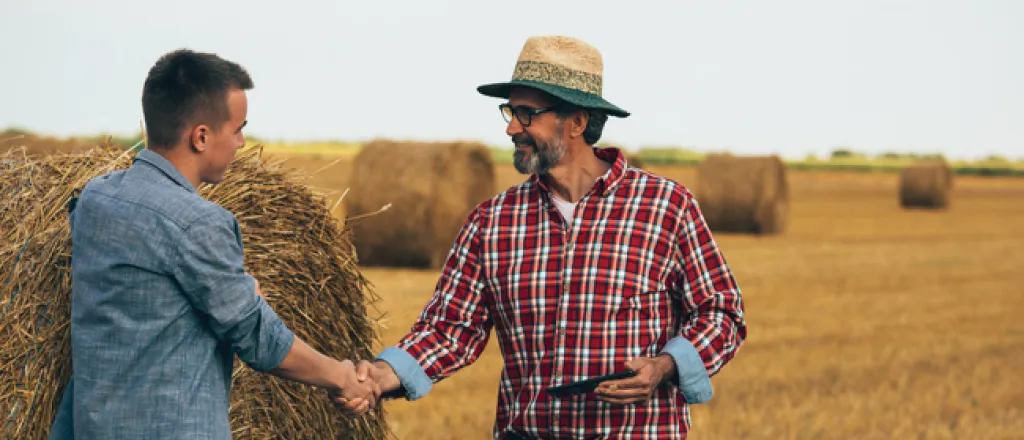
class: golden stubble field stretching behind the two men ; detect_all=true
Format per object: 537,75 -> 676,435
274,156 -> 1024,440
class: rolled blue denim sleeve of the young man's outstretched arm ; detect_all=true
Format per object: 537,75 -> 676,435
173,209 -> 294,371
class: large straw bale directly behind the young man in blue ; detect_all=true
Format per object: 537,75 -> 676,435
0,145 -> 390,439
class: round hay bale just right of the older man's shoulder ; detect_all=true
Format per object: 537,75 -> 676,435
694,155 -> 790,234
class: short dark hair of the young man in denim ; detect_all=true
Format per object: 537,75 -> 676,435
142,49 -> 253,148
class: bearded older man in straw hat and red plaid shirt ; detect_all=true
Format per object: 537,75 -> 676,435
339,37 -> 746,439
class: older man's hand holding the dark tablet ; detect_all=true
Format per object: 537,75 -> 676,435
594,354 -> 676,404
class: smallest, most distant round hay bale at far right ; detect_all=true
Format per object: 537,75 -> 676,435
899,161 -> 953,209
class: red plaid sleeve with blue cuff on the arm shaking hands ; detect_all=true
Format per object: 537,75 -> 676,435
377,209 -> 494,400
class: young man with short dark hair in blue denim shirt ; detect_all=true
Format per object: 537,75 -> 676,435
50,50 -> 379,440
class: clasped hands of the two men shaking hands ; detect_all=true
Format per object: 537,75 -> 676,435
327,360 -> 401,416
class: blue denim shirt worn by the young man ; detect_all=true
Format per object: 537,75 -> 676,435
50,150 -> 294,440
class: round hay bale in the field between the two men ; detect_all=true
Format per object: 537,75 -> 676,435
344,140 -> 496,268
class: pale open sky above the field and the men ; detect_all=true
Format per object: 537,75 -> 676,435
0,0 -> 1024,159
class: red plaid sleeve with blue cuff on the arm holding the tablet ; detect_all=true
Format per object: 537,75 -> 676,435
663,190 -> 746,403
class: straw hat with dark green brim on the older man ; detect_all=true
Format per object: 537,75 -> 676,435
476,36 -> 630,118
